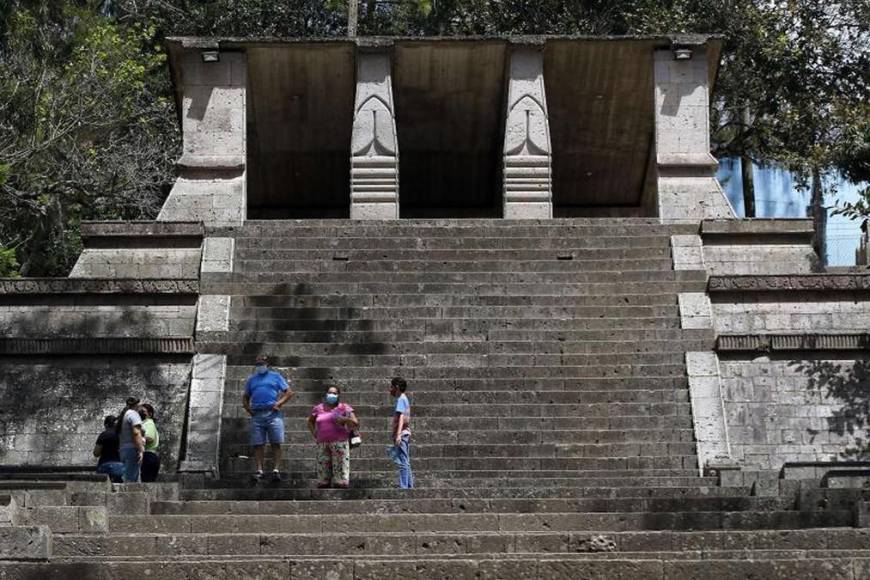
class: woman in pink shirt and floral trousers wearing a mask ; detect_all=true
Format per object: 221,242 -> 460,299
308,387 -> 359,488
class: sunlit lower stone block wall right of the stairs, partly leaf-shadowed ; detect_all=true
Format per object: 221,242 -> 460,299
719,353 -> 870,469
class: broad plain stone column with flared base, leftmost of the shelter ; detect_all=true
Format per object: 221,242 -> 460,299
157,49 -> 247,225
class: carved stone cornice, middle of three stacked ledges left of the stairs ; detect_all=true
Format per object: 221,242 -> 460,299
0,278 -> 199,296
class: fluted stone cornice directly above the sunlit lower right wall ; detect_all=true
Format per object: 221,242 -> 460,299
716,333 -> 870,352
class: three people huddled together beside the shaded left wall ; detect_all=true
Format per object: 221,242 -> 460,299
94,397 -> 160,483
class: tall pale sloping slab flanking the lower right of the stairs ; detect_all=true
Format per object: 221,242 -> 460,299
686,352 -> 731,475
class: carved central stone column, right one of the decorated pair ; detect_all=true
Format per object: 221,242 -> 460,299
504,47 -> 553,219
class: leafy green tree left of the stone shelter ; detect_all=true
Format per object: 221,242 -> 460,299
0,1 -> 177,276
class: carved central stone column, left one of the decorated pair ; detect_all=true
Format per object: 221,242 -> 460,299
350,51 -> 399,220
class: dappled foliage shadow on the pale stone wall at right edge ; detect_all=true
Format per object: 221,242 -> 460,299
790,352 -> 870,460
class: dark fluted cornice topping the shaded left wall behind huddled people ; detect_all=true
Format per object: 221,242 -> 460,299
0,336 -> 194,355
